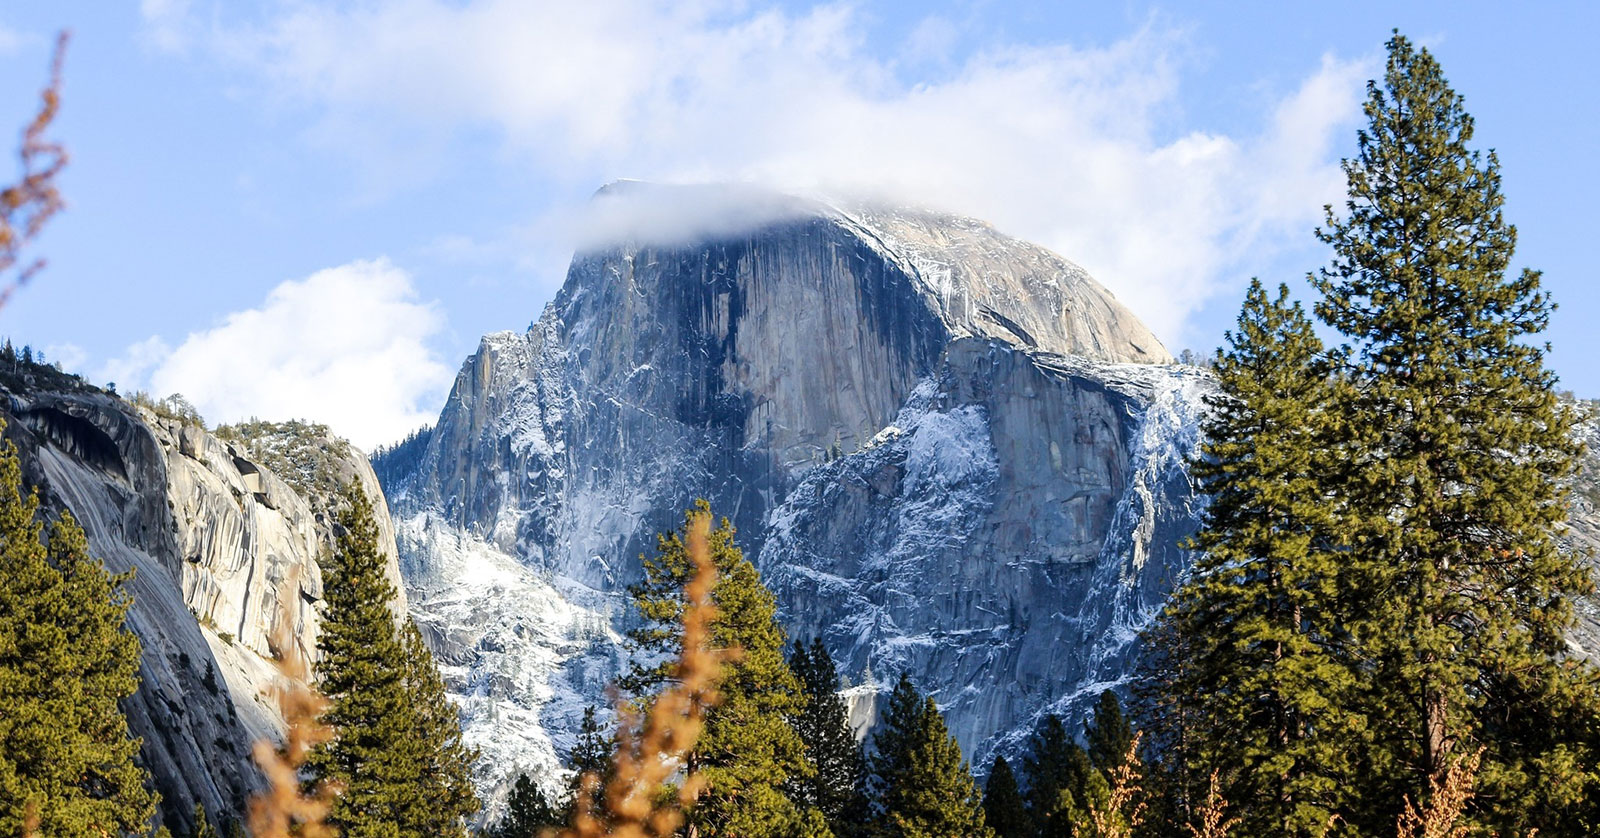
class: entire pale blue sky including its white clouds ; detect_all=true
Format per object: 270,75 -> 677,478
0,0 -> 1600,446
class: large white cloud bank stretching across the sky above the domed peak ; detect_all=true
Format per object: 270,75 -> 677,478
152,0 -> 1366,341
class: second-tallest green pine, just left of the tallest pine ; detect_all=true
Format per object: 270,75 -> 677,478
1150,281 -> 1360,835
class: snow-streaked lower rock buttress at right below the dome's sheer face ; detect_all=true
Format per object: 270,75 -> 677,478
760,341 -> 1211,763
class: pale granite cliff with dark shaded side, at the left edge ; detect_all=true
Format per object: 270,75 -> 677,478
0,371 -> 405,830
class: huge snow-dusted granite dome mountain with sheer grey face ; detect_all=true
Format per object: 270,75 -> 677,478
376,179 -> 1208,796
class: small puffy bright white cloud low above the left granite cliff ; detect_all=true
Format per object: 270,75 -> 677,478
101,259 -> 451,449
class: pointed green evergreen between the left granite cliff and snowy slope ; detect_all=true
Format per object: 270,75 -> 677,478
307,486 -> 477,838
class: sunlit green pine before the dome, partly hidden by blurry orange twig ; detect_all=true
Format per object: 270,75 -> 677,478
621,501 -> 813,838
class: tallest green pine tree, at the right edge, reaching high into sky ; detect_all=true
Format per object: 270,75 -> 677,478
1314,34 -> 1600,835
